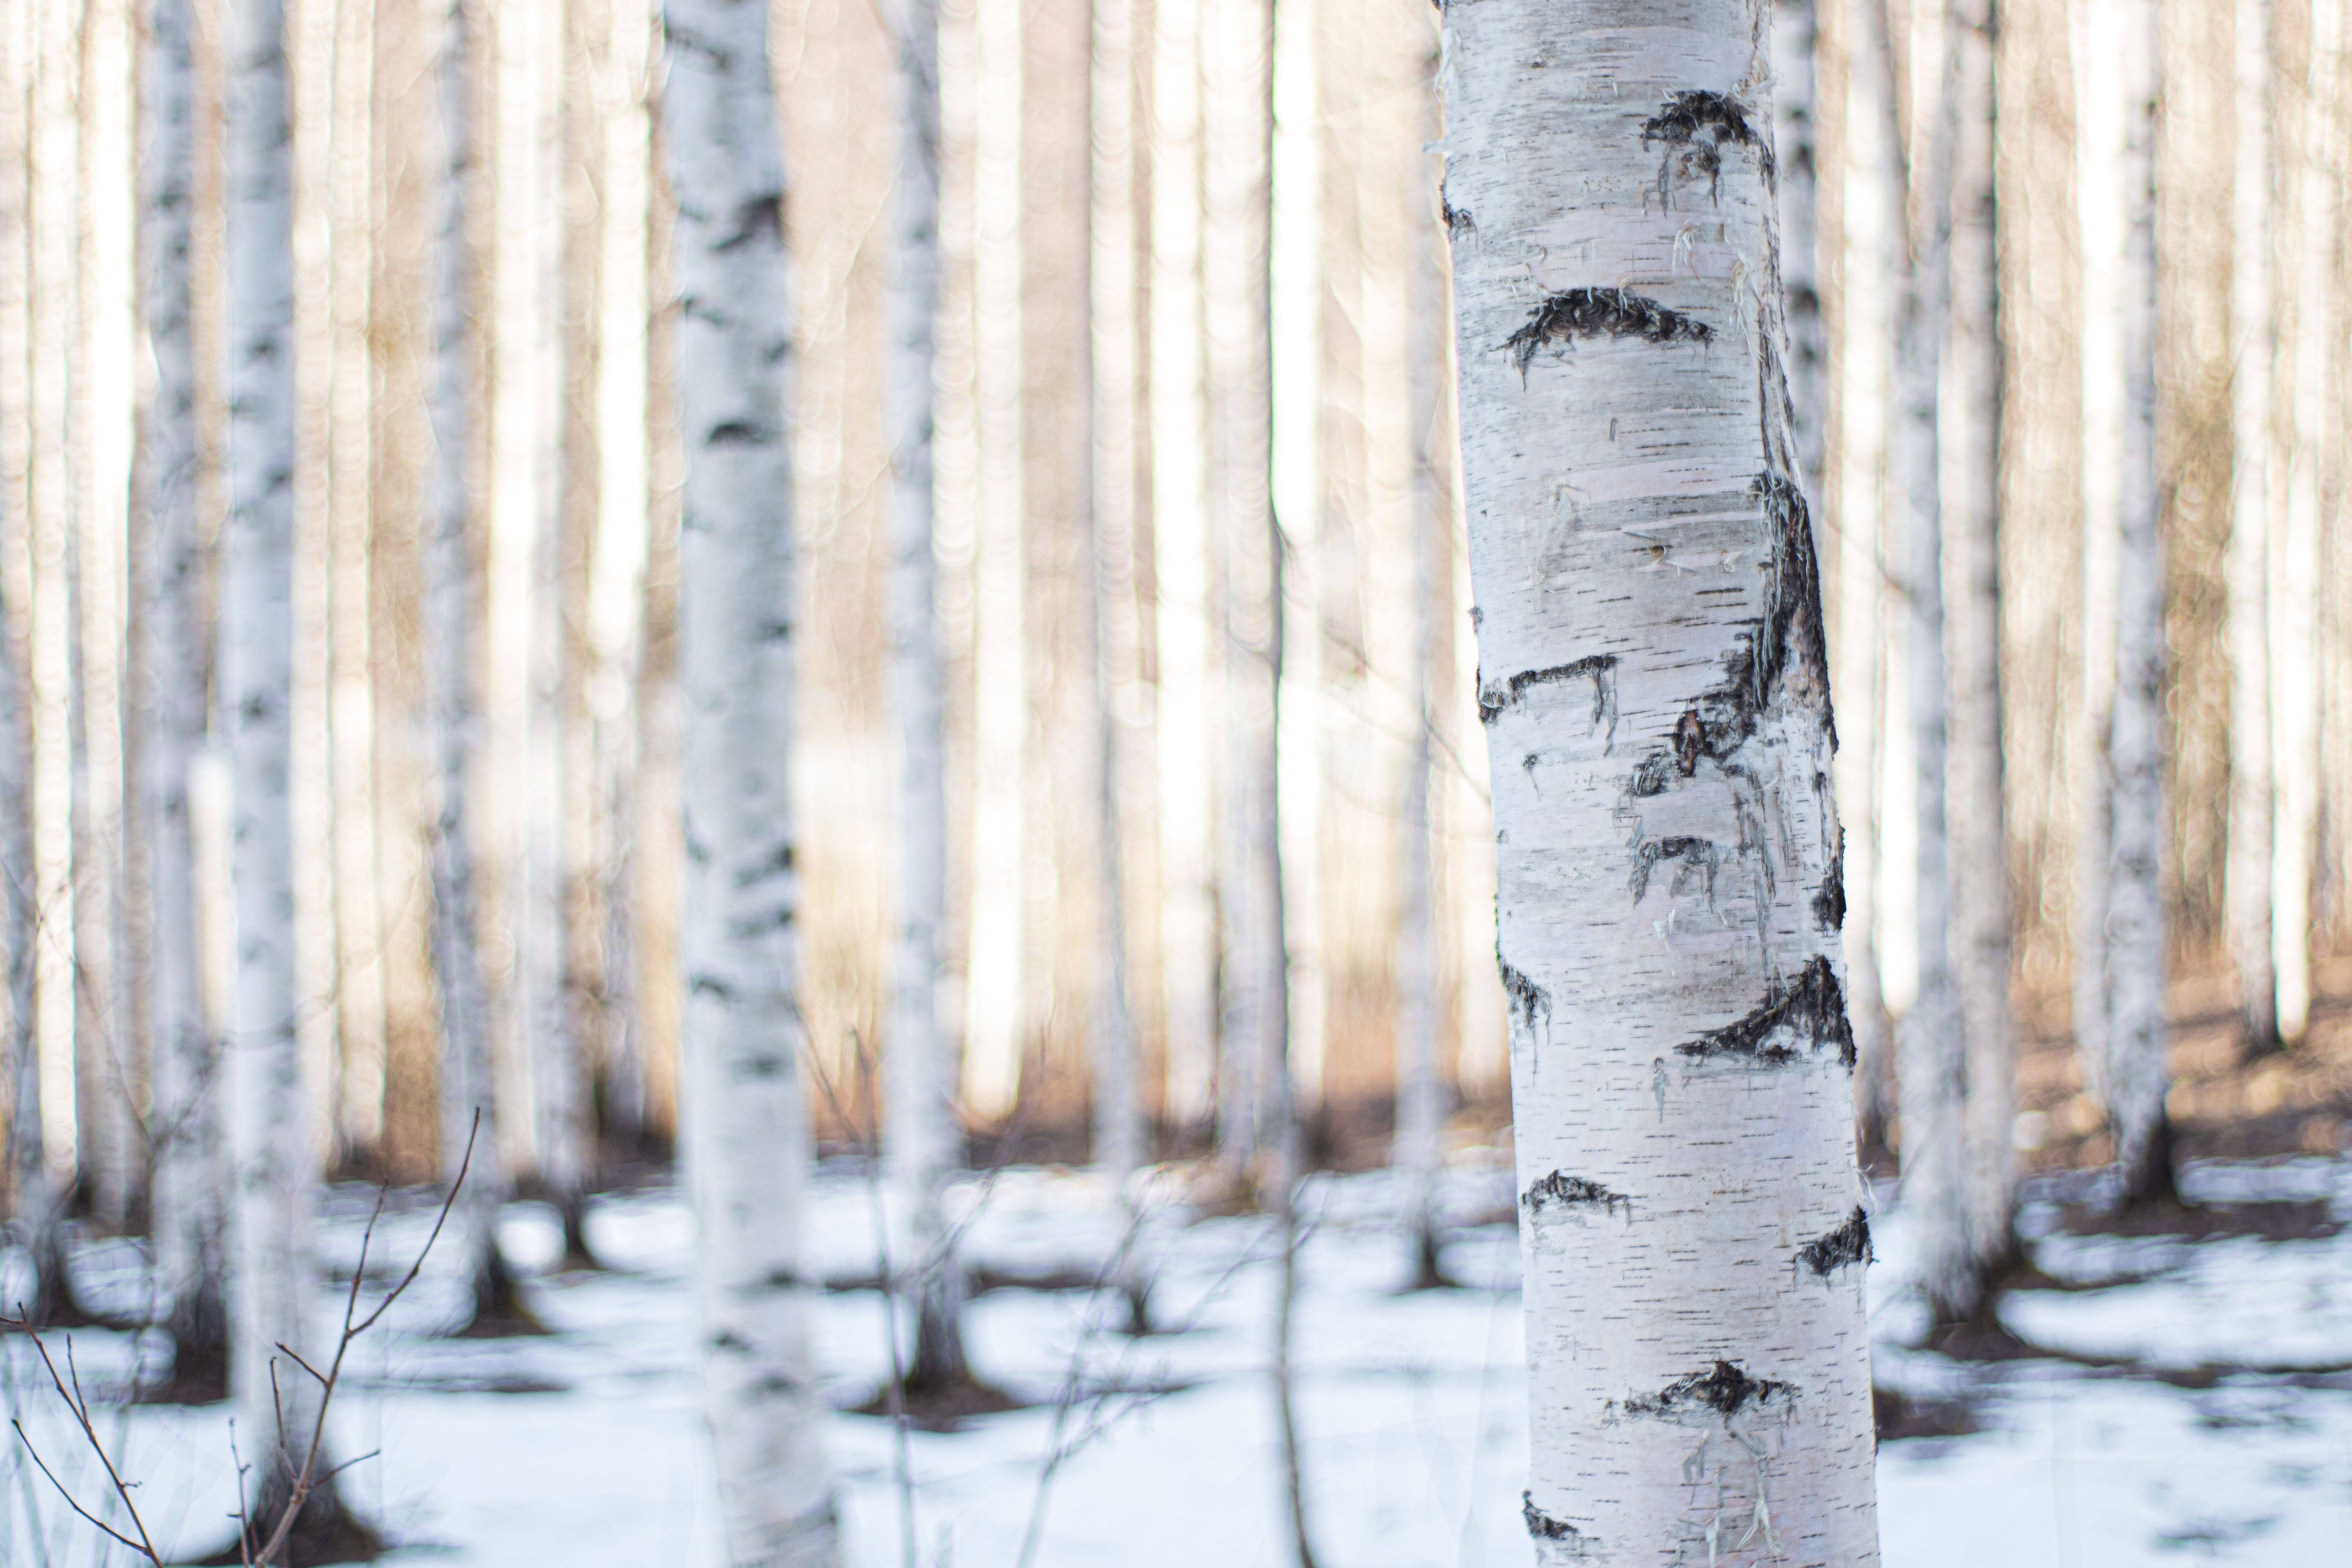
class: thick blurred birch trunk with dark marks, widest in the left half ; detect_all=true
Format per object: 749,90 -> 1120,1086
661,0 -> 840,1568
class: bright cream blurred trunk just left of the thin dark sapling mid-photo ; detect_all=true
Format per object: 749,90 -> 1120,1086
1202,0 -> 1289,1190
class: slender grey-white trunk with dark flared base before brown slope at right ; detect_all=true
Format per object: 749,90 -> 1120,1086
2107,0 -> 2173,1204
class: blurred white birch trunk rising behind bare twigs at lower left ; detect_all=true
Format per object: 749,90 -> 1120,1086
219,0 -> 360,1561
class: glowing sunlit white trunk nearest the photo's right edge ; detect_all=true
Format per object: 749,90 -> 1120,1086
2270,0 -> 2343,1044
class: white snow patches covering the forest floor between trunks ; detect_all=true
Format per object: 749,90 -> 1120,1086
0,1161 -> 2352,1568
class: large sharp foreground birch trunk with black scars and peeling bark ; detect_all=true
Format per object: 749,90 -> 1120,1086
1444,0 -> 1877,1566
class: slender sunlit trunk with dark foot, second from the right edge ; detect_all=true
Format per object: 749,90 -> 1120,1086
2223,0 -> 2279,1056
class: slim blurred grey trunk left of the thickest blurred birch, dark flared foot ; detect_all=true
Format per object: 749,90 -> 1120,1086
423,0 -> 536,1333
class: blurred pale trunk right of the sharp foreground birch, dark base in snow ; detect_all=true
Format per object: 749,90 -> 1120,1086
1872,7 -> 1976,1321
